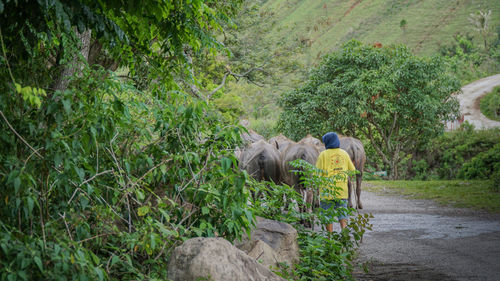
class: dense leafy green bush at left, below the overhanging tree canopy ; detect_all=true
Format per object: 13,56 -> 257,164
0,65 -> 253,280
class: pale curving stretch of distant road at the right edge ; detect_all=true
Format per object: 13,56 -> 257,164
457,74 -> 500,129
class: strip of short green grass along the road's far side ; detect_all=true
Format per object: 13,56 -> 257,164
364,180 -> 500,213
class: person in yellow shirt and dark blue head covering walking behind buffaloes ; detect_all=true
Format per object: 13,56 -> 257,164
316,132 -> 356,232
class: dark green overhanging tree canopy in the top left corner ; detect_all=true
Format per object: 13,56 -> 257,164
0,0 -> 241,94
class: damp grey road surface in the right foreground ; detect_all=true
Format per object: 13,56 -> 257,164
354,186 -> 500,281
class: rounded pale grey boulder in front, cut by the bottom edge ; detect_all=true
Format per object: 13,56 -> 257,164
168,238 -> 284,281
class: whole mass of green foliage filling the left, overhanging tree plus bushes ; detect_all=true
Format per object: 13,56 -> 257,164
0,0 -> 253,280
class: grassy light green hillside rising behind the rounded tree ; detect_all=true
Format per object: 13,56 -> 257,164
228,0 -> 500,135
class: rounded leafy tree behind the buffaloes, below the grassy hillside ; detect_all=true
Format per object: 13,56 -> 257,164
279,41 -> 460,178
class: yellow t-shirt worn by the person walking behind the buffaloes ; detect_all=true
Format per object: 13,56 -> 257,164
316,148 -> 356,200
